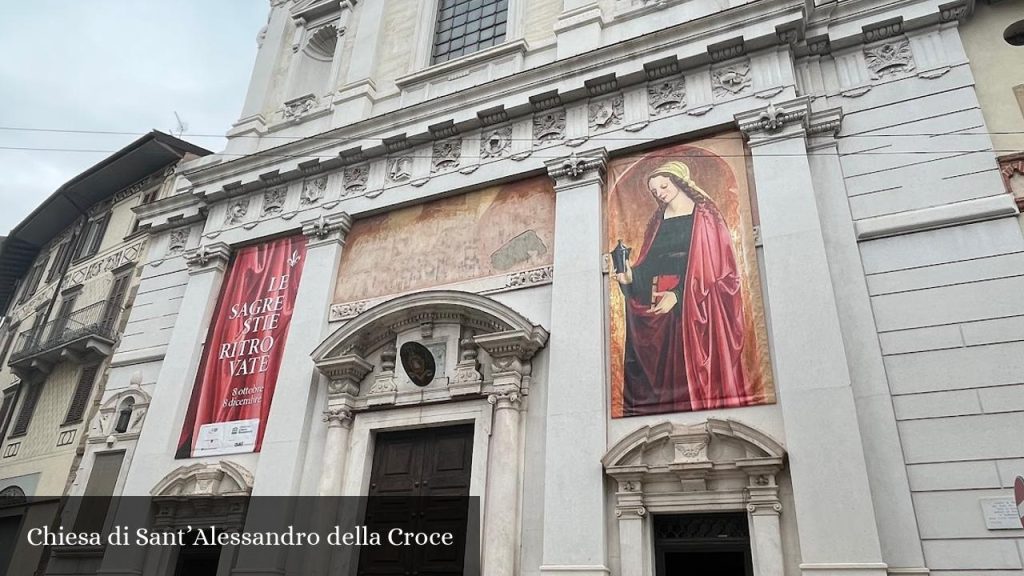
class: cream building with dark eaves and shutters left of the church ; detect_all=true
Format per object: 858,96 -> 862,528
0,131 -> 209,574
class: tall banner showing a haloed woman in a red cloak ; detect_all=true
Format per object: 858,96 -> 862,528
607,133 -> 775,418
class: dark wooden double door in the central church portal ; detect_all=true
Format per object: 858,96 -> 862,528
358,425 -> 473,576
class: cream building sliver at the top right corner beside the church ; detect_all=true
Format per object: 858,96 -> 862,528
963,0 -> 1024,214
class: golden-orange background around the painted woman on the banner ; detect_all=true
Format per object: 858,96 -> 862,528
606,132 -> 775,418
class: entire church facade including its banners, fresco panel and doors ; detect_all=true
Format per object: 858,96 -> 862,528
18,0 -> 1024,576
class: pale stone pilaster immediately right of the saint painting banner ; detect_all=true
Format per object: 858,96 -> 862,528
736,98 -> 886,576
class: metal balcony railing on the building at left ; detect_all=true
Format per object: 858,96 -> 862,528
9,300 -> 117,363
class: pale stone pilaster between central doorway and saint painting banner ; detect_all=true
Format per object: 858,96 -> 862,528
541,147 -> 608,576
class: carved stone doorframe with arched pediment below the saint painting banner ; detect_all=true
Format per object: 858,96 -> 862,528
601,418 -> 785,576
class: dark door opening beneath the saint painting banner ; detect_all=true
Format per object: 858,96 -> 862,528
654,513 -> 754,576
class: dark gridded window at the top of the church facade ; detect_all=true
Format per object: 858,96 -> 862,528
431,0 -> 509,64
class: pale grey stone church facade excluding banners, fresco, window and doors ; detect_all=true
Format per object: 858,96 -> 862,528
8,0 -> 1024,576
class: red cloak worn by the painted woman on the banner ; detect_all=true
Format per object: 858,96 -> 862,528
624,201 -> 756,415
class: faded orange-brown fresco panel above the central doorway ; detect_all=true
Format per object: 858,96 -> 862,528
334,176 -> 555,302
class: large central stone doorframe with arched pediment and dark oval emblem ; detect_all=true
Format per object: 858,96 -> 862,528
311,290 -> 548,576
